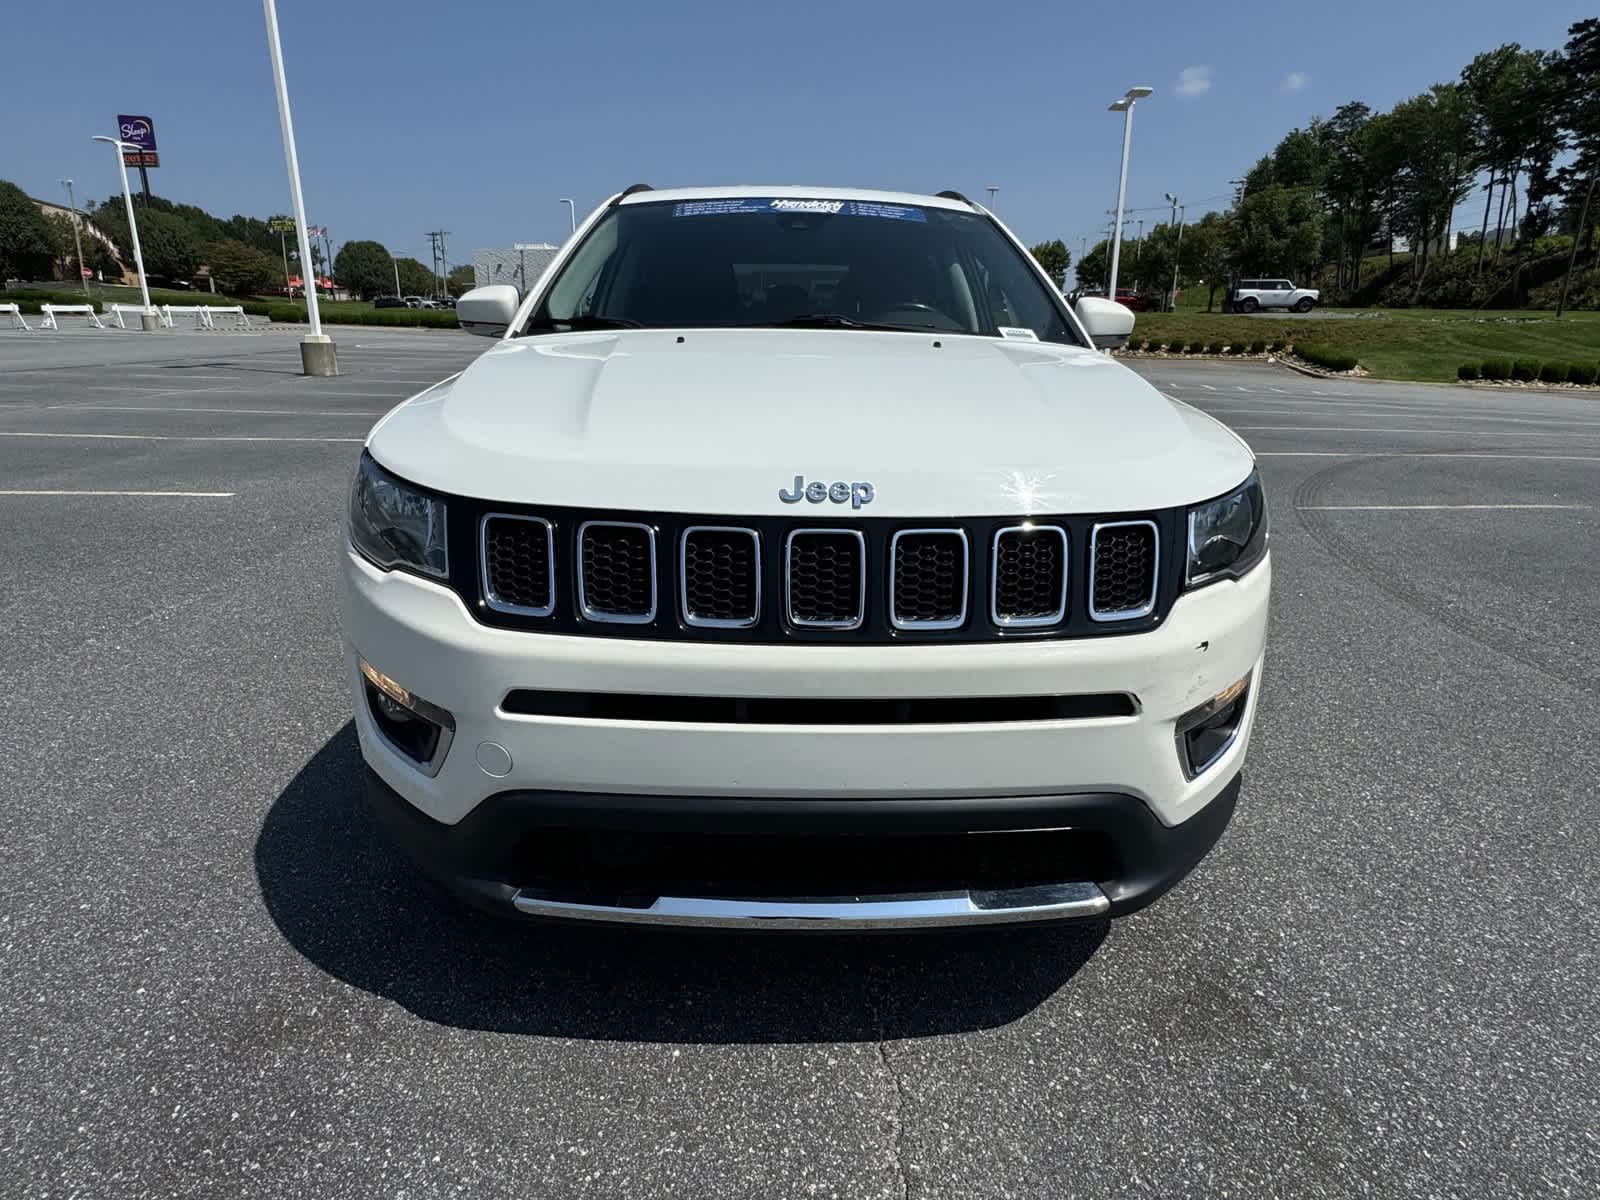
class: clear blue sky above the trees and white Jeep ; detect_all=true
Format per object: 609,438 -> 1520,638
0,0 -> 1594,261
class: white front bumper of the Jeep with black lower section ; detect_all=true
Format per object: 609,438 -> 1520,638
344,550 -> 1270,928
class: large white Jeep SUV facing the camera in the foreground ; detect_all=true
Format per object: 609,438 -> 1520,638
342,187 -> 1270,928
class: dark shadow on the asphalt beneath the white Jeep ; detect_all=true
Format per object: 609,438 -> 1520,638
256,725 -> 1107,1043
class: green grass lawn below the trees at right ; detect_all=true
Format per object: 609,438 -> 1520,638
1133,309 -> 1600,381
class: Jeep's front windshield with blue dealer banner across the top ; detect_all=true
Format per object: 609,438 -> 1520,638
522,197 -> 1082,346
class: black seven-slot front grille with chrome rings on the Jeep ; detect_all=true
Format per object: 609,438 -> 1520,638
467,499 -> 1184,645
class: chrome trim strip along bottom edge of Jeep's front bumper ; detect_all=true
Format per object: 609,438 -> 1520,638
512,883 -> 1110,931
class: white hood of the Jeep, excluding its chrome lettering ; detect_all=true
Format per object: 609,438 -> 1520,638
370,330 -> 1251,518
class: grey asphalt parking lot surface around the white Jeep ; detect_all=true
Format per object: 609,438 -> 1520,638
0,330 -> 1600,1200
